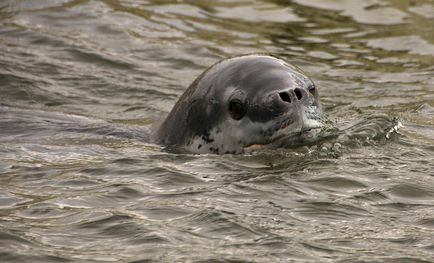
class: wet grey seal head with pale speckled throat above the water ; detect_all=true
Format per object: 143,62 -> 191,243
152,55 -> 323,154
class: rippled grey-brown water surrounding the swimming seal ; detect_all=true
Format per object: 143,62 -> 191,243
0,0 -> 434,262
